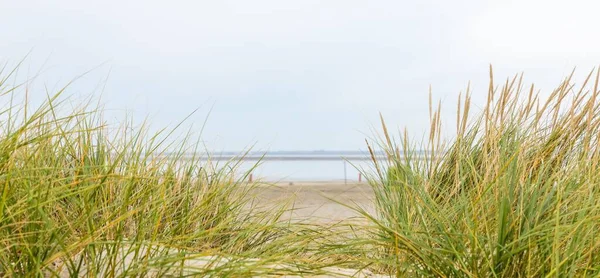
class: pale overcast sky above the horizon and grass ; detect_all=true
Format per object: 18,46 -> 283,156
0,0 -> 600,150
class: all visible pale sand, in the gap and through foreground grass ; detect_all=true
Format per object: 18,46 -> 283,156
49,181 -> 382,277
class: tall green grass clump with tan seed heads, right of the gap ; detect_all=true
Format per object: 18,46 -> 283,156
365,69 -> 600,277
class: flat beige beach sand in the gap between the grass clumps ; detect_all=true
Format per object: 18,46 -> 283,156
250,181 -> 374,223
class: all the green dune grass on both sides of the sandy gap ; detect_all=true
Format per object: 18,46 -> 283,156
0,62 -> 600,277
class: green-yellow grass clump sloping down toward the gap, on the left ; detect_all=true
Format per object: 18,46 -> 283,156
0,67 -> 356,277
